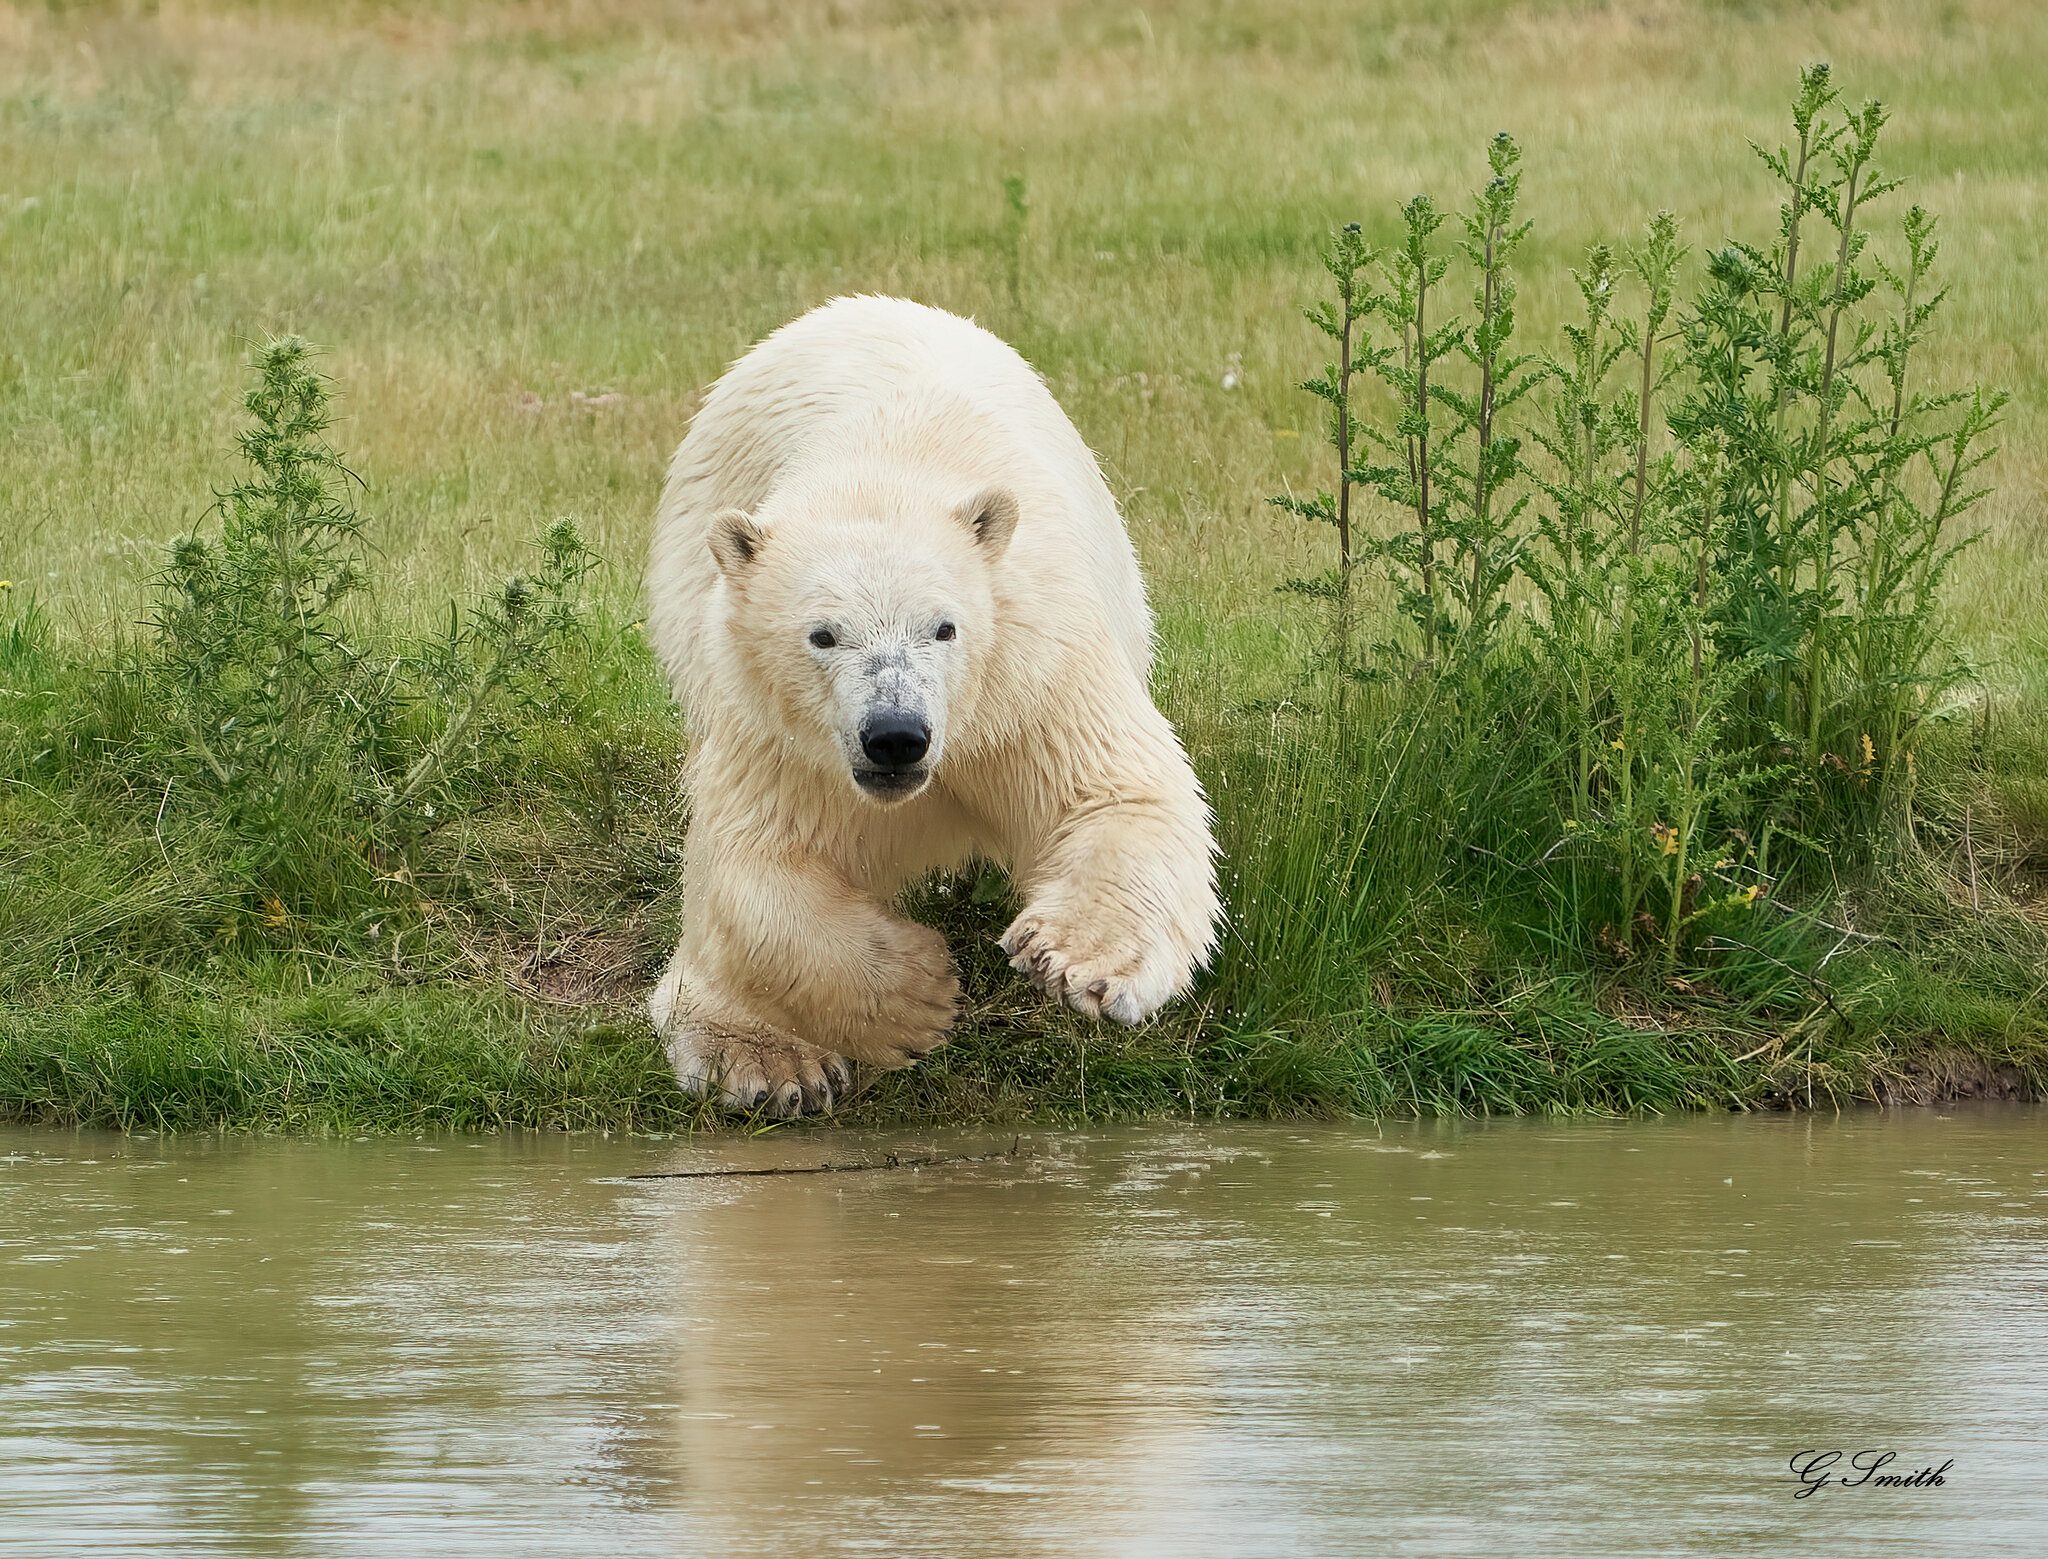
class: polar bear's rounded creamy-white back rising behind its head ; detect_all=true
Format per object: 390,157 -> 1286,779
647,297 -> 1151,694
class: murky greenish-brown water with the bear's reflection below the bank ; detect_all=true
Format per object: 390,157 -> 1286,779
0,1108 -> 2048,1555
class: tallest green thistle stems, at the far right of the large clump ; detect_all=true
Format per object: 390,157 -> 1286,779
1673,66 -> 2005,824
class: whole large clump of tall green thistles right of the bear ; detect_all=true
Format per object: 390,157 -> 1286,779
1274,66 -> 2005,973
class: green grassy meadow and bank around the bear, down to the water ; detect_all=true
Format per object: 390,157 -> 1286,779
0,0 -> 2048,1131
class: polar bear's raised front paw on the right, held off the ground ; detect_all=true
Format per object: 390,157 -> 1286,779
1001,760 -> 1221,1024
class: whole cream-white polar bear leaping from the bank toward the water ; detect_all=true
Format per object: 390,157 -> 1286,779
647,297 -> 1221,1116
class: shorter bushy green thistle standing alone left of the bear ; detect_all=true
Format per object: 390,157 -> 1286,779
129,338 -> 596,928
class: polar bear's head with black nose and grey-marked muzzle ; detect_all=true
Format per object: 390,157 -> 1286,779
711,488 -> 1018,805
